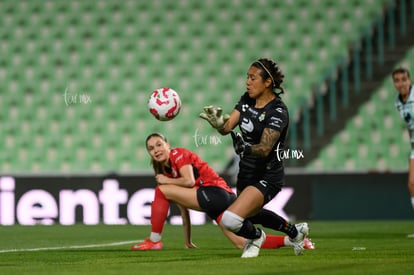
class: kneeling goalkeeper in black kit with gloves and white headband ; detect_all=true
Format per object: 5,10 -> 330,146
200,58 -> 309,257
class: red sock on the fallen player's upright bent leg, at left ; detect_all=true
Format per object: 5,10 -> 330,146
151,187 -> 170,233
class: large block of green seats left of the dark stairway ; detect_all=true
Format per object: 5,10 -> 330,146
0,0 -> 388,172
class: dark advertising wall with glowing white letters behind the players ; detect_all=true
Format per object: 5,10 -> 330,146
0,173 -> 413,225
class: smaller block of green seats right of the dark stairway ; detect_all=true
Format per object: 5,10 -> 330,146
307,48 -> 414,170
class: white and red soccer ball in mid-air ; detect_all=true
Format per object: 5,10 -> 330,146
148,88 -> 181,121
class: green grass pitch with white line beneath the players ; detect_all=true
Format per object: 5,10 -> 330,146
0,221 -> 414,274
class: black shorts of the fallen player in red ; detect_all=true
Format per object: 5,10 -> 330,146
197,186 -> 236,220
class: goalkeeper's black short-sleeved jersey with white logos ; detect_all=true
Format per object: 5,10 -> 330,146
235,92 -> 289,183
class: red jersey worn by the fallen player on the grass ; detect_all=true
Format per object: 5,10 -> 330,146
166,148 -> 233,193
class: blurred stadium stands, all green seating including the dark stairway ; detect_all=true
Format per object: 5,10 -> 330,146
0,0 -> 414,174
